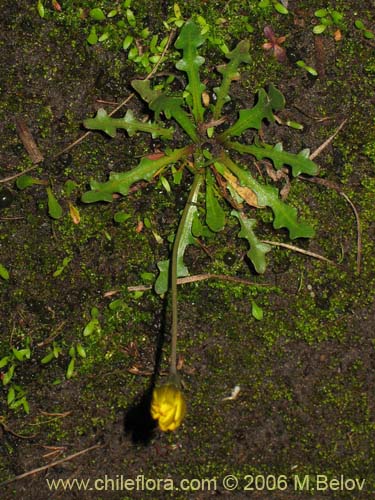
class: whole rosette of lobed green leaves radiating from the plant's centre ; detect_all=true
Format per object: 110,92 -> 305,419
82,21 -> 317,293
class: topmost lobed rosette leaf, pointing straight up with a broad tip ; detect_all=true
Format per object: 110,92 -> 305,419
174,21 -> 206,123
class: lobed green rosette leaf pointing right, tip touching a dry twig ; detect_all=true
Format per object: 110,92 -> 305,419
226,142 -> 318,177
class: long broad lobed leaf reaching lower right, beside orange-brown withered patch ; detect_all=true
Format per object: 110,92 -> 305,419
215,154 -> 315,239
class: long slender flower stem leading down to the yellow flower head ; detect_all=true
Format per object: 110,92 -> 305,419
169,173 -> 203,376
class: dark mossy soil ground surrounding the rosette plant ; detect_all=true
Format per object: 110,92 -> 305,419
0,0 -> 375,500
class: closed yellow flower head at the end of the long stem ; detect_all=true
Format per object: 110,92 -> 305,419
151,383 -> 186,431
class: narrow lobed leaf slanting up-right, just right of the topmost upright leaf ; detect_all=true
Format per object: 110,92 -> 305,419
213,40 -> 251,120
